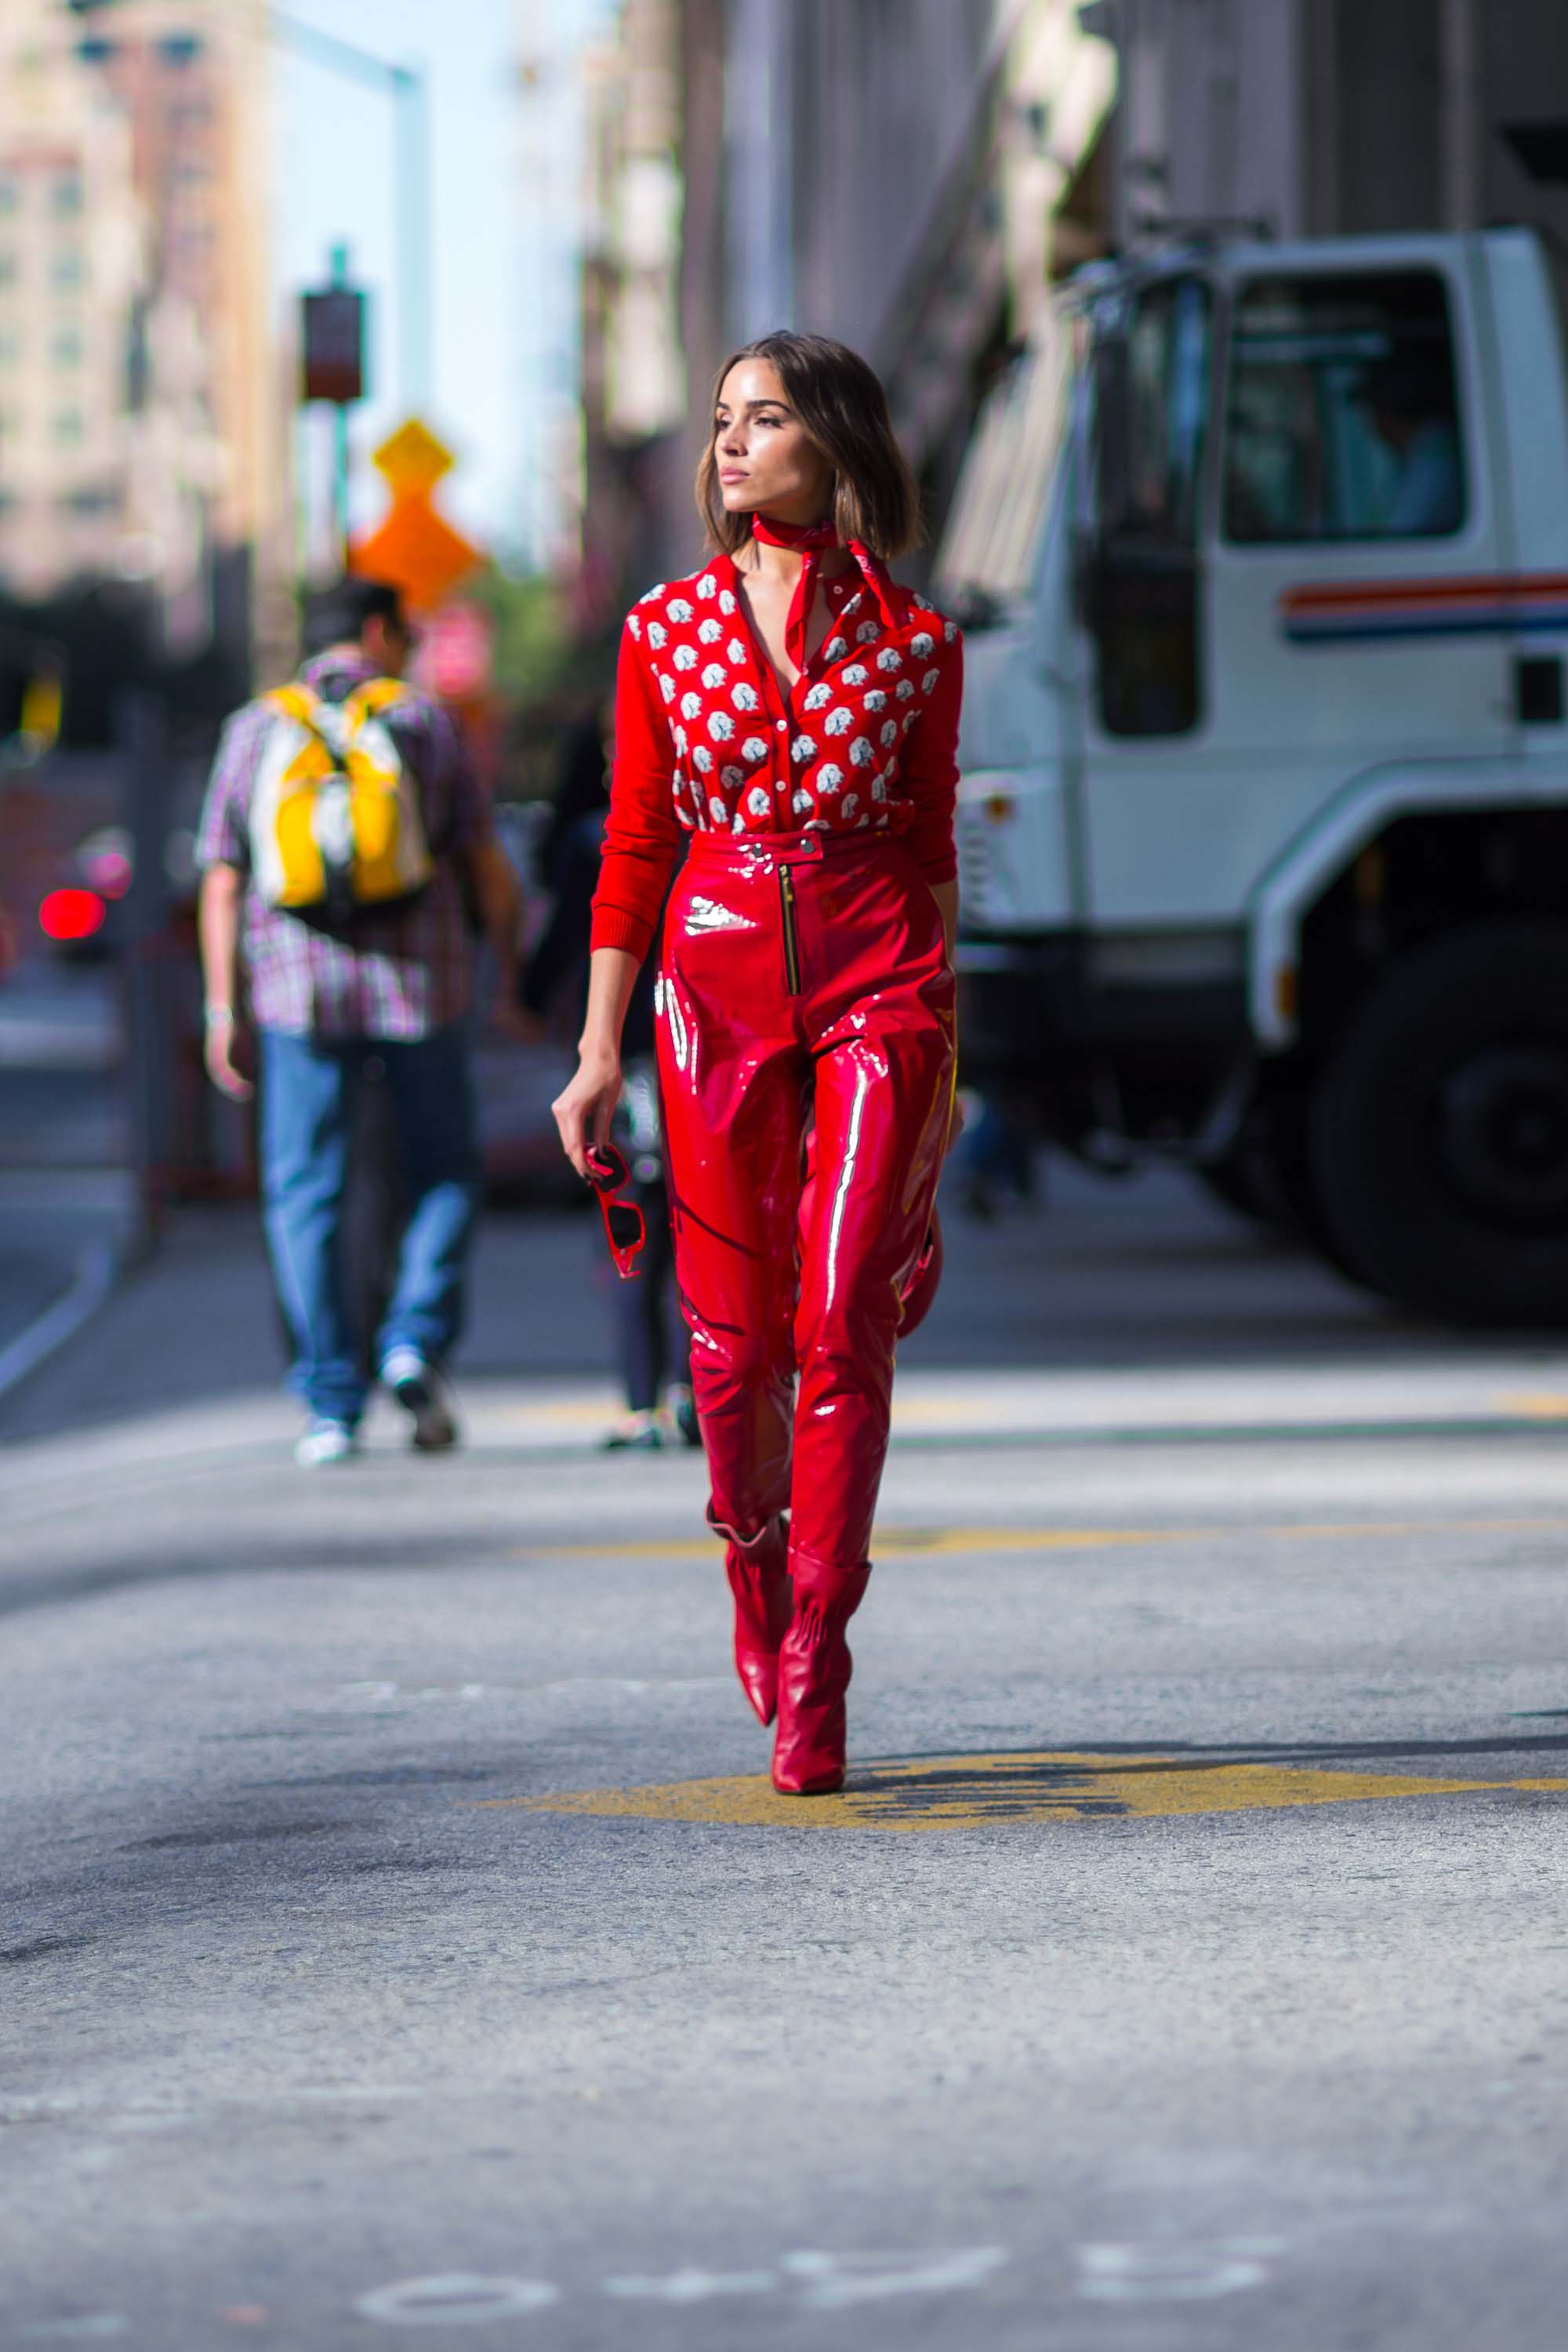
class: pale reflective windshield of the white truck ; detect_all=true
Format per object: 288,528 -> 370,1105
933,336 -> 1072,628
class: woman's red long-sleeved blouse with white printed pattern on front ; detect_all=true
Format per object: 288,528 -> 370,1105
593,550 -> 964,955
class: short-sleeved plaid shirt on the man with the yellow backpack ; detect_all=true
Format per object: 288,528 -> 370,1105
195,652 -> 489,1037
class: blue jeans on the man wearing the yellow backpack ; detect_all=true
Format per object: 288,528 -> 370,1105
261,1023 -> 480,1425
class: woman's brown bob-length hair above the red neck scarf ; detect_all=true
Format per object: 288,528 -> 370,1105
696,329 -> 919,562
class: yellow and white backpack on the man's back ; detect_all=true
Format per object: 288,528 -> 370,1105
249,677 -> 435,927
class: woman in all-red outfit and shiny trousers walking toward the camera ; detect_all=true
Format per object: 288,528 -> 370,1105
555,334 -> 961,1795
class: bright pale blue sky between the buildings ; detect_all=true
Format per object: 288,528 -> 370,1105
273,0 -> 614,564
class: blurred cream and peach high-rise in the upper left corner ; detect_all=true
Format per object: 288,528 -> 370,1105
0,0 -> 292,687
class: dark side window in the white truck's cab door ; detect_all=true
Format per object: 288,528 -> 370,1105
1225,270 -> 1465,546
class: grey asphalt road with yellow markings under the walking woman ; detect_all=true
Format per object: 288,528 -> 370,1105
0,1178 -> 1568,2352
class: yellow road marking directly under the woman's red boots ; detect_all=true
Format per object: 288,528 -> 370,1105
477,1752 -> 1568,1830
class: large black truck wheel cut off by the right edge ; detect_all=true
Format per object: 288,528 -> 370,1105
1307,920 -> 1568,1329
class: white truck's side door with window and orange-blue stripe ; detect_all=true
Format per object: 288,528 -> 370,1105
1086,245 -> 1509,929
